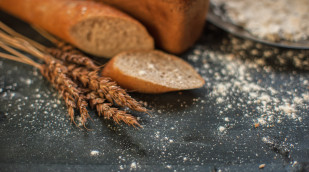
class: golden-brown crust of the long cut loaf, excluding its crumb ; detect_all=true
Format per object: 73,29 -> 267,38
0,0 -> 154,55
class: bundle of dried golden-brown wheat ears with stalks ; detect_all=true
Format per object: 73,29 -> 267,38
0,22 -> 148,128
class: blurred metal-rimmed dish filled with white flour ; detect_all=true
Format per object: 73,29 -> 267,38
208,0 -> 309,49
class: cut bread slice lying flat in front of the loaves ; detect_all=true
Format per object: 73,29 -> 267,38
102,50 -> 205,93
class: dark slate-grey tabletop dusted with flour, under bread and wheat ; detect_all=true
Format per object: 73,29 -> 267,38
0,12 -> 309,171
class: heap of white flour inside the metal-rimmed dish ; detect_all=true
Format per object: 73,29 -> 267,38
211,0 -> 309,41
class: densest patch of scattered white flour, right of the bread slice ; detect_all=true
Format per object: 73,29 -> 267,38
189,34 -> 309,129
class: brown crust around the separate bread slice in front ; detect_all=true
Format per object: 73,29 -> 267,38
102,50 -> 205,94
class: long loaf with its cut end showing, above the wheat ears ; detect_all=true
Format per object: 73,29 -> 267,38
0,0 -> 154,57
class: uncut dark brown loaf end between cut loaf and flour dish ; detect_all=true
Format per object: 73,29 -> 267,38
96,0 -> 209,54
